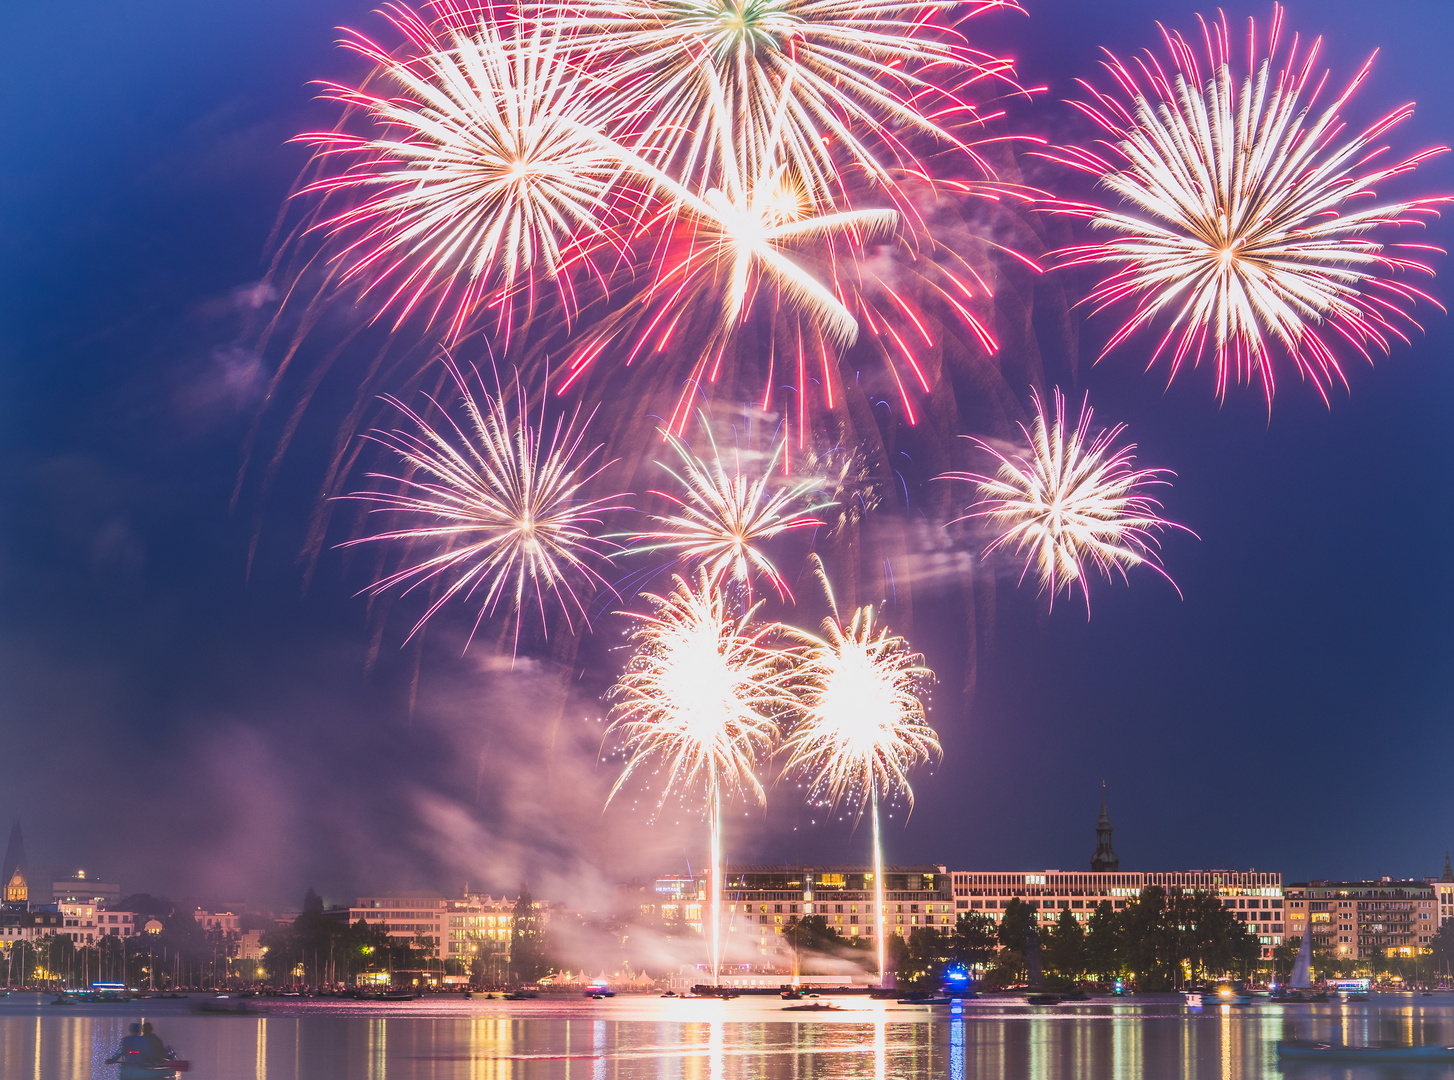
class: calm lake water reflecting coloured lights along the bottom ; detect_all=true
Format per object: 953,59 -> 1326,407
0,994 -> 1454,1080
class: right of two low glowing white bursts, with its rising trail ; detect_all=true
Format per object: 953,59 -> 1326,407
782,564 -> 942,983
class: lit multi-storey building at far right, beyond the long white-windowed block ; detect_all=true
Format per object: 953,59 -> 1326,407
1287,878 -> 1441,959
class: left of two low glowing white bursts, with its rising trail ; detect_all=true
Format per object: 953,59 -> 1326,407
606,571 -> 794,986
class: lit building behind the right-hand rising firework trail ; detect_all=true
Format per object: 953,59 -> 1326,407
723,865 -> 955,956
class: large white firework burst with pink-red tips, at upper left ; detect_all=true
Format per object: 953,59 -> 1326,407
298,6 -> 622,336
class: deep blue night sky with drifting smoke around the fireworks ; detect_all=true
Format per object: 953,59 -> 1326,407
0,0 -> 1454,900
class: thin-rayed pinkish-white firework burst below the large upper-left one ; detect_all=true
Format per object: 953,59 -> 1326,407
343,360 -> 625,644
